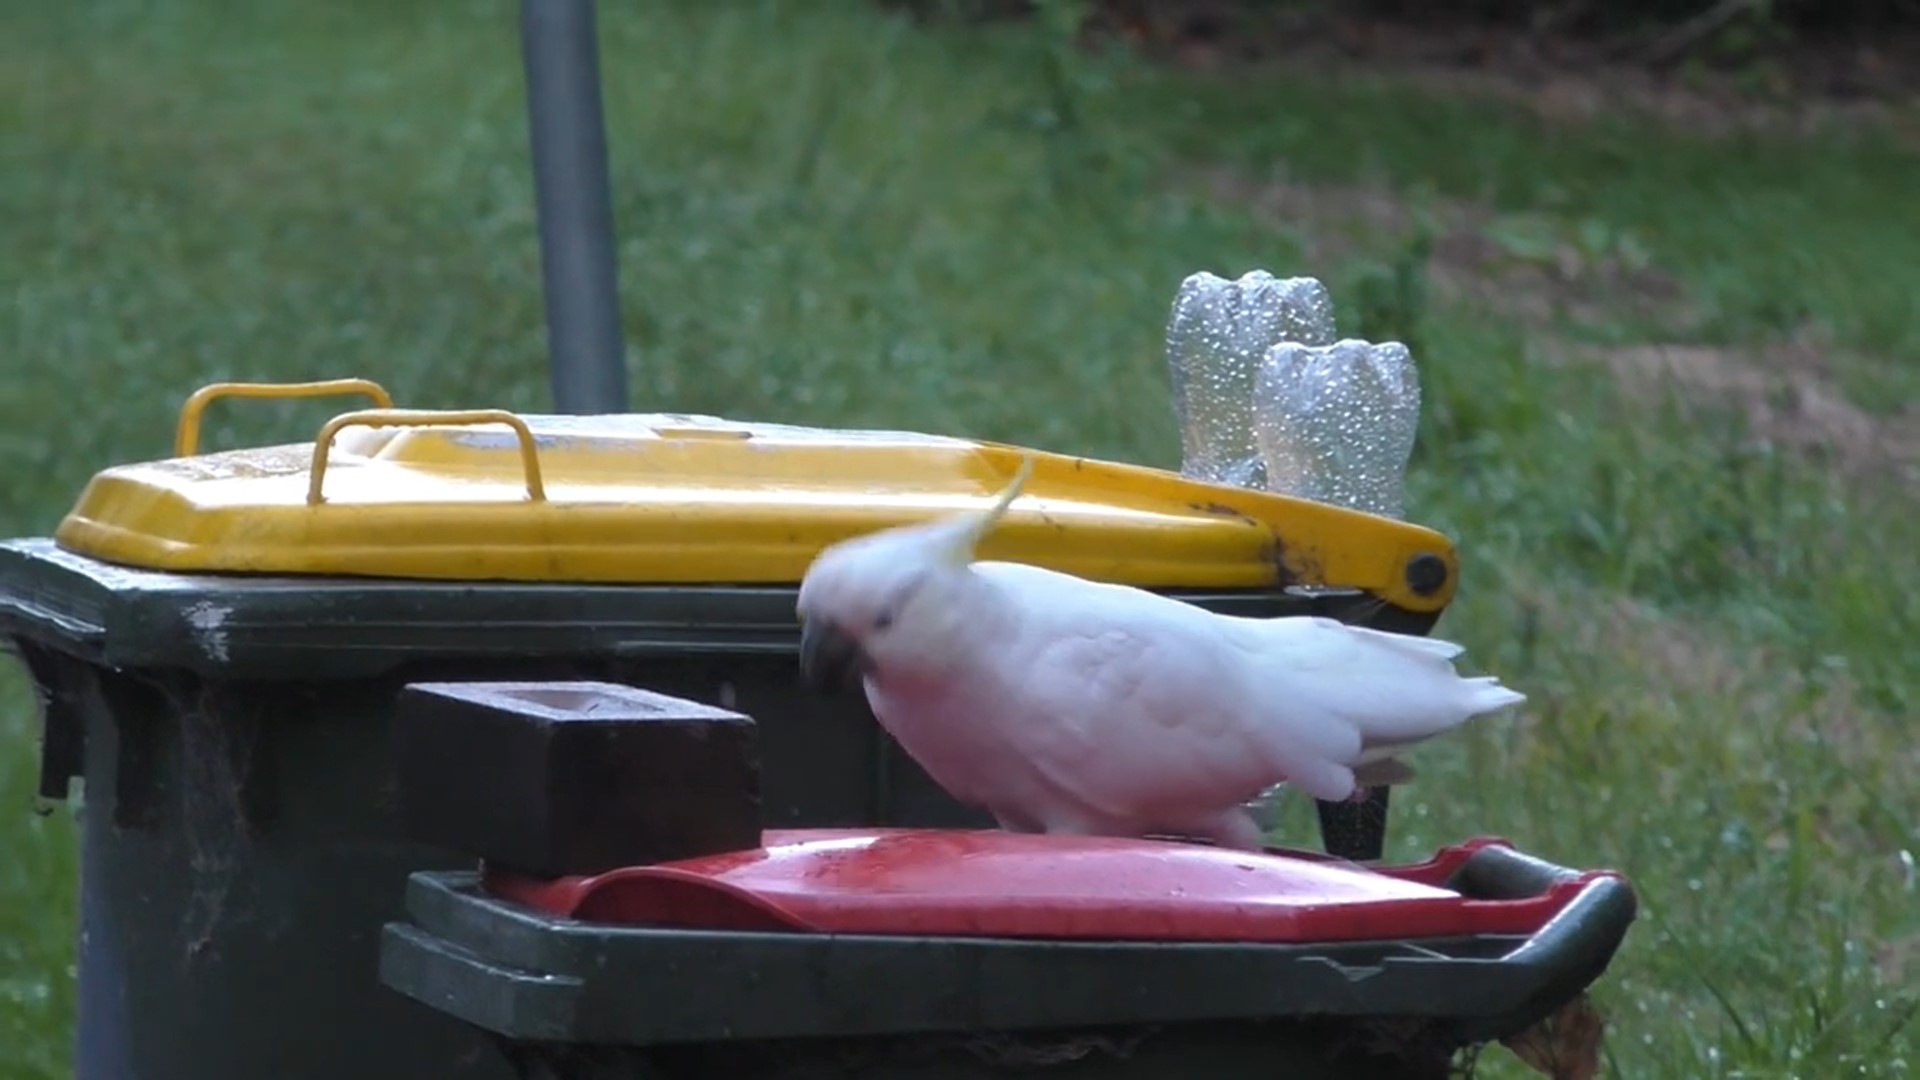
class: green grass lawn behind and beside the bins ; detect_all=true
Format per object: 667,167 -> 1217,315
0,0 -> 1920,1078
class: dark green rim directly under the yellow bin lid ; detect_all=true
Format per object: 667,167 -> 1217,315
0,536 -> 1436,678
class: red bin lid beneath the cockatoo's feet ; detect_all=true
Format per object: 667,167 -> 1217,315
484,828 -> 1592,944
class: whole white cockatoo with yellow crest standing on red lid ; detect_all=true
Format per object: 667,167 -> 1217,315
797,457 -> 1524,849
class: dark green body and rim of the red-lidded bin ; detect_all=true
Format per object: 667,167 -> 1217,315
382,842 -> 1636,1080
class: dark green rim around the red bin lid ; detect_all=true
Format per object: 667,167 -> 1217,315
380,826 -> 1638,1047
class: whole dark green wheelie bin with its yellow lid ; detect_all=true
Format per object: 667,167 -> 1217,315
0,382 -> 1455,1080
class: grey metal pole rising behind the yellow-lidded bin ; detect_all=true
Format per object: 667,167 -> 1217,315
520,0 -> 626,413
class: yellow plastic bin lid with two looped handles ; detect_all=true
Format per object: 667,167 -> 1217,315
56,380 -> 1457,611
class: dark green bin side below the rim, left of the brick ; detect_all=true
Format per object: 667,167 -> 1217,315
58,659 -> 507,1080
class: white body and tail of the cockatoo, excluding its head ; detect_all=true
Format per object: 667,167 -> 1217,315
852,563 -> 1524,840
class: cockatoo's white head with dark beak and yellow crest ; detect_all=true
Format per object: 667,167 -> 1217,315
797,455 -> 1033,688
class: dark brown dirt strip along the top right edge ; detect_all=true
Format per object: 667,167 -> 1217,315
881,0 -> 1920,146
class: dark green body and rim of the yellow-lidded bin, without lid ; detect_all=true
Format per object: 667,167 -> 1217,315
0,542 -> 1428,1080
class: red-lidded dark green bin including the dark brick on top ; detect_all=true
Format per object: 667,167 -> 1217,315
370,680 -> 1636,1080
